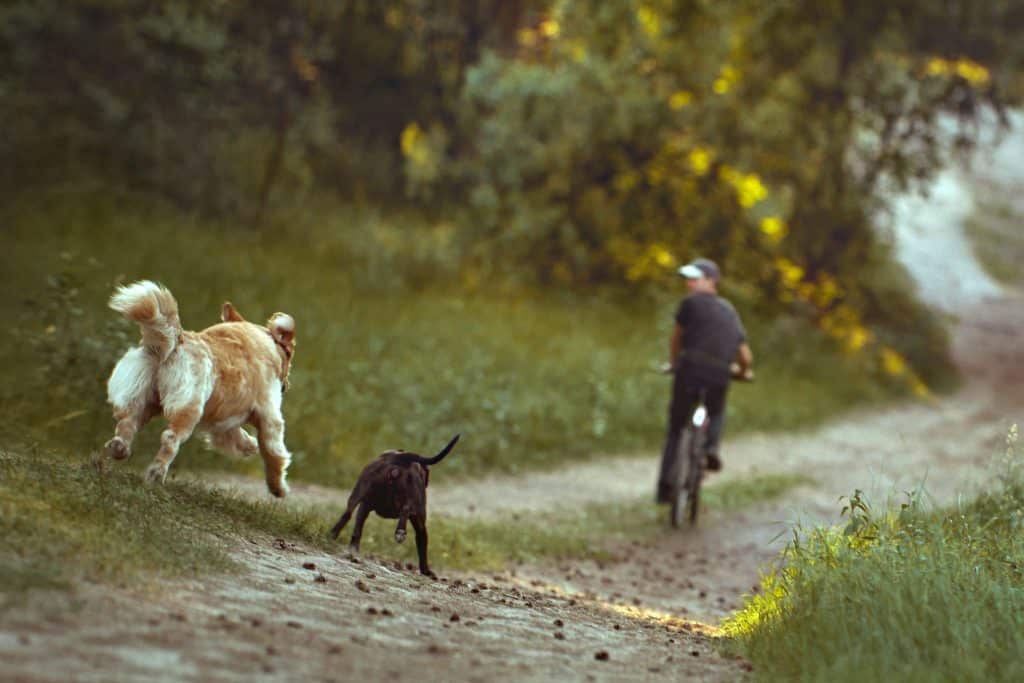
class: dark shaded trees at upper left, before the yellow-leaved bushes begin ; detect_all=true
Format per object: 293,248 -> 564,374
0,0 -> 534,209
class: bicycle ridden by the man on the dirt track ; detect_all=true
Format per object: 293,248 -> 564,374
669,364 -> 754,528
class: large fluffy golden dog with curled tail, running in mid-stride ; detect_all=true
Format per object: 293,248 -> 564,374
103,281 -> 295,498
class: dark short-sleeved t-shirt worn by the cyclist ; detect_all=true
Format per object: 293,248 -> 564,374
676,292 -> 746,385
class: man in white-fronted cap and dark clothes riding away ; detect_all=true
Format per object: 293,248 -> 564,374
656,258 -> 754,503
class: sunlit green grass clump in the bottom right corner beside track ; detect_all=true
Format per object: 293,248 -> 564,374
724,423 -> 1024,681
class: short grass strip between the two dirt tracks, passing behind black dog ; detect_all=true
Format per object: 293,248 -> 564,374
0,438 -> 807,604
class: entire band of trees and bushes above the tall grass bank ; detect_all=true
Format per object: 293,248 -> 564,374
0,0 -> 1024,385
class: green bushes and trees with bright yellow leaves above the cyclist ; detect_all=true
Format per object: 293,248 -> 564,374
421,0 -> 1021,394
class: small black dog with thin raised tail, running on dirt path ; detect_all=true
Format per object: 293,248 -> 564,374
331,434 -> 461,577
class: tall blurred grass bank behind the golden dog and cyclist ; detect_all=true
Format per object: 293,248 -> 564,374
0,189 -> 905,485
